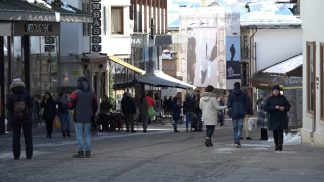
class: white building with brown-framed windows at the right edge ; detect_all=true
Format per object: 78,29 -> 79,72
300,0 -> 324,146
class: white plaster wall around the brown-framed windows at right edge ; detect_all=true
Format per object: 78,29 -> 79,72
300,0 -> 324,146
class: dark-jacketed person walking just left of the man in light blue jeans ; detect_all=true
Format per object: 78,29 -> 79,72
56,92 -> 71,137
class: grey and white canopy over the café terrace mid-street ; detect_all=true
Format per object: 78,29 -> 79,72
136,71 -> 196,89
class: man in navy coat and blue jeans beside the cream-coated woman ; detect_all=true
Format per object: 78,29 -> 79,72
227,82 -> 249,148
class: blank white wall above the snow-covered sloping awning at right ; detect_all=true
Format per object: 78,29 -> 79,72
254,29 -> 302,71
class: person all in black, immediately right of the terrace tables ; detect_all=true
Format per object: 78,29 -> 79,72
121,92 -> 136,133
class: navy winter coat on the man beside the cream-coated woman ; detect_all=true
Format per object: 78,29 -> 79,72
227,88 -> 250,119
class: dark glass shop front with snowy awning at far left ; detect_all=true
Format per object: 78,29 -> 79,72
0,1 -> 92,134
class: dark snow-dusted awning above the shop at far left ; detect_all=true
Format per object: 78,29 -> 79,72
0,0 -> 93,23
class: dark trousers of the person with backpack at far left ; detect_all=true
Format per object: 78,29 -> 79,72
12,123 -> 33,158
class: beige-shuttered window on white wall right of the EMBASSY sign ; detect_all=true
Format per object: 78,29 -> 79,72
111,7 -> 124,34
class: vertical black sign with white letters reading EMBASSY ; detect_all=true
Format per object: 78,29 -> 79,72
91,0 -> 101,52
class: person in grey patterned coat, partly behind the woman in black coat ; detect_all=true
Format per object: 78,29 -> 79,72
256,95 -> 268,140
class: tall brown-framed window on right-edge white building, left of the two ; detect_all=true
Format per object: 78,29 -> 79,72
307,42 -> 316,114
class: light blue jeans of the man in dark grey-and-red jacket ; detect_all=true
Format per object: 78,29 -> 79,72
75,122 -> 91,151
